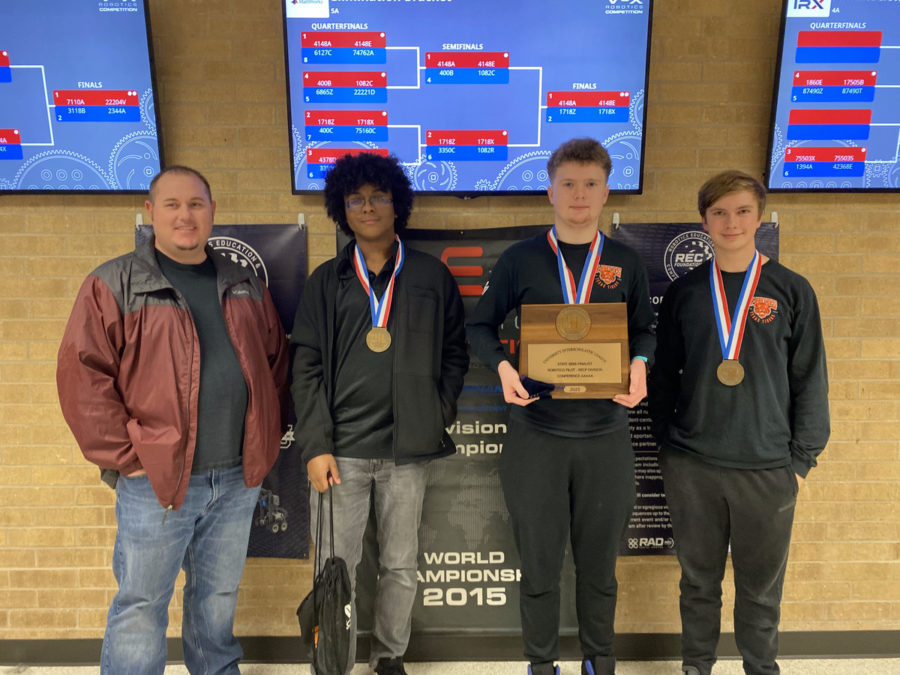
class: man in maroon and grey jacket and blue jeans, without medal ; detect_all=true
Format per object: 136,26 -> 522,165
57,166 -> 288,675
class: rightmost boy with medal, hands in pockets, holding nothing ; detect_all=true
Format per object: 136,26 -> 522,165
650,171 -> 829,675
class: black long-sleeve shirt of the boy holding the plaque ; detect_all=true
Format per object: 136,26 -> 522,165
467,232 -> 655,437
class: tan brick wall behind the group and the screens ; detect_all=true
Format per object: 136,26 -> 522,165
0,0 -> 900,639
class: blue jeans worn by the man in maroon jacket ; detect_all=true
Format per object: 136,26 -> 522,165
100,465 -> 260,675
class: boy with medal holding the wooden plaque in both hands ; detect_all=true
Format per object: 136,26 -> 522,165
468,138 -> 655,675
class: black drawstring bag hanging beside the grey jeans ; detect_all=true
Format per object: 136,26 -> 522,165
297,489 -> 353,675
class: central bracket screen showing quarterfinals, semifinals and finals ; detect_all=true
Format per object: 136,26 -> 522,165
284,0 -> 652,194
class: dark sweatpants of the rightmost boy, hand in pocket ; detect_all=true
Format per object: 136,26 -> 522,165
660,449 -> 797,675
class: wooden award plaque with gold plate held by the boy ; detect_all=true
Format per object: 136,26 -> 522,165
519,302 -> 629,398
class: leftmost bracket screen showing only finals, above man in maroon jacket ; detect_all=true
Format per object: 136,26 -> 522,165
0,0 -> 161,193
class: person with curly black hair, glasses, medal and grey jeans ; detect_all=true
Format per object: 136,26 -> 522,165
291,153 -> 469,675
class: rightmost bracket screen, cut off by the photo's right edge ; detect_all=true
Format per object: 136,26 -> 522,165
768,0 -> 900,192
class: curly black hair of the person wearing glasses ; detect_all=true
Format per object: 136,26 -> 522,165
324,152 -> 413,237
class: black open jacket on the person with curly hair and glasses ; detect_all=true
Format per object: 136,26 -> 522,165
291,242 -> 469,464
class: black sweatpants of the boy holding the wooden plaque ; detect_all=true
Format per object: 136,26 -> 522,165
500,420 -> 635,672
